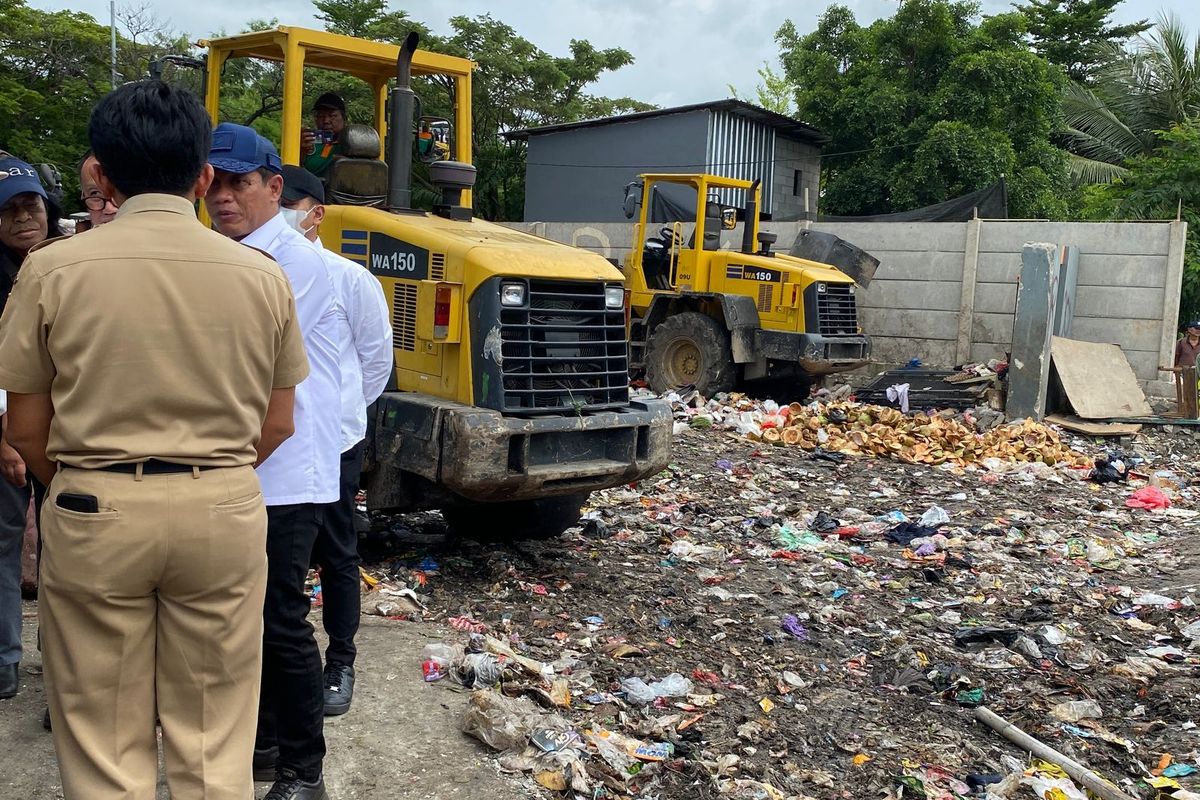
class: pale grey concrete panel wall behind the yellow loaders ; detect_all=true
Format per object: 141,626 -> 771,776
501,219 -> 1187,397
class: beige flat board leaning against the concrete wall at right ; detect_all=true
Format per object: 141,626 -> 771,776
1050,336 -> 1154,420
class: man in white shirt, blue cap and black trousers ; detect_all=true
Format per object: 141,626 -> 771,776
204,122 -> 341,800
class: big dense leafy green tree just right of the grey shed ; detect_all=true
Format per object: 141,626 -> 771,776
775,0 -> 1069,217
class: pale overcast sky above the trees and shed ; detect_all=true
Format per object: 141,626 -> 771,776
29,0 -> 1200,107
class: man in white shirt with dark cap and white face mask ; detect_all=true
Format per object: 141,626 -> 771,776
282,164 -> 392,716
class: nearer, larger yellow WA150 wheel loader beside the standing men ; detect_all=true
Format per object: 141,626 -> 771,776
195,28 -> 672,537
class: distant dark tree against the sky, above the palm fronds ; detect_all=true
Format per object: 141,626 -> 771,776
1013,0 -> 1151,83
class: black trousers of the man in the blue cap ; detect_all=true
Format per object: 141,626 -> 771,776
254,503 -> 325,781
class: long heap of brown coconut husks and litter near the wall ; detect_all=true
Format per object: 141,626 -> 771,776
667,393 -> 1092,467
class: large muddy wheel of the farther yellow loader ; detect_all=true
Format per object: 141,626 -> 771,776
646,311 -> 737,397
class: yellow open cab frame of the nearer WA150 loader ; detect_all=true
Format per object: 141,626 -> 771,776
199,25 -> 475,205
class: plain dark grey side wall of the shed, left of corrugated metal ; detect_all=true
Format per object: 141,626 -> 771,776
524,109 -> 708,222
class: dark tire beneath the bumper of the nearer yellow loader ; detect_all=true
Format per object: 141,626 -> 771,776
442,492 -> 590,542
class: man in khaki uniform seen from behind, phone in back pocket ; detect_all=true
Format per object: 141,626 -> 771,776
0,82 -> 308,800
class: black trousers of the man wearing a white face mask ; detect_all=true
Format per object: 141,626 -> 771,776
312,441 -> 364,667
